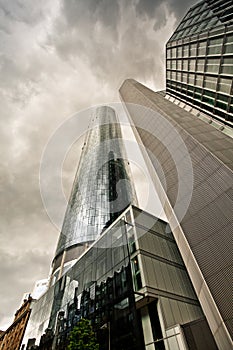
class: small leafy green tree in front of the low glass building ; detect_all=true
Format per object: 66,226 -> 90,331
67,318 -> 99,350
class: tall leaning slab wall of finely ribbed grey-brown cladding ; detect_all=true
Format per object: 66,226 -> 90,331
120,80 -> 233,342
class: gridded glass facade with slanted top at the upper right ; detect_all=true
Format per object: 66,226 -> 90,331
166,0 -> 233,126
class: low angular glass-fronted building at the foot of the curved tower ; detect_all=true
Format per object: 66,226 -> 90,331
23,207 -> 211,350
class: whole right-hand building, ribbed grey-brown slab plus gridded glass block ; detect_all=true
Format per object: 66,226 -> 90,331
120,0 -> 233,349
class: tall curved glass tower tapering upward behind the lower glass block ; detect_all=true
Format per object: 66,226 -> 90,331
52,106 -> 136,281
